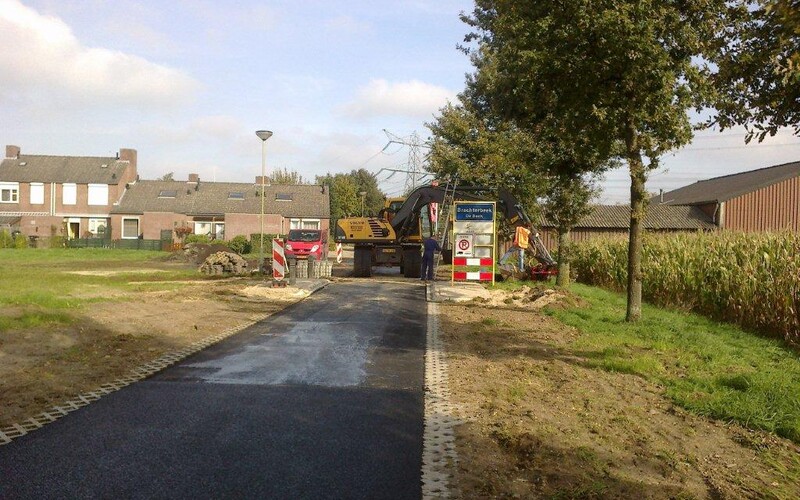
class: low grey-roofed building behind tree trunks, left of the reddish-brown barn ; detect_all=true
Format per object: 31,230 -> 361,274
539,204 -> 716,250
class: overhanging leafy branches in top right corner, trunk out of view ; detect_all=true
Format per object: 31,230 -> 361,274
710,0 -> 800,142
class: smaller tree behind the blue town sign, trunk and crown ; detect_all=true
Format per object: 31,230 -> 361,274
428,101 -> 612,287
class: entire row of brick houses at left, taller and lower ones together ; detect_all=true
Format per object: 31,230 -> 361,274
0,146 -> 330,244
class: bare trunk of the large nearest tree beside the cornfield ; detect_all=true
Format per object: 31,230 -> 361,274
625,120 -> 647,322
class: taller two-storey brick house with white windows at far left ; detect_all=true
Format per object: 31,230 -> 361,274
0,145 -> 137,238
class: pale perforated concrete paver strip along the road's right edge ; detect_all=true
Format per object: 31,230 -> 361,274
422,294 -> 458,499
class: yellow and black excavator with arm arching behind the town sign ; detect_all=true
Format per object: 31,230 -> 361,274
334,185 -> 556,278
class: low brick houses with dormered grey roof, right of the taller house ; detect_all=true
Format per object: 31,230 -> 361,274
111,174 -> 330,240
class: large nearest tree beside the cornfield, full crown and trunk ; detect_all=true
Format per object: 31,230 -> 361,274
464,0 -> 728,321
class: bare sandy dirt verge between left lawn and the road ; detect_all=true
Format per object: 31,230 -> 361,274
0,278 -> 308,428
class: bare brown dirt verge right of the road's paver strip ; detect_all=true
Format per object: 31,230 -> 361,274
440,300 -> 800,498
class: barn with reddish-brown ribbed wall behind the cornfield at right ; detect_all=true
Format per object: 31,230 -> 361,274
650,162 -> 800,231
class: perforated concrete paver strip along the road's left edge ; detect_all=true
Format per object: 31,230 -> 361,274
0,280 -> 330,446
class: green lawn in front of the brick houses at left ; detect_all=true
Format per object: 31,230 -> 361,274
0,248 -> 196,331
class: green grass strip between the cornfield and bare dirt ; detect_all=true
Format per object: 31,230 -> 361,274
545,284 -> 800,443
